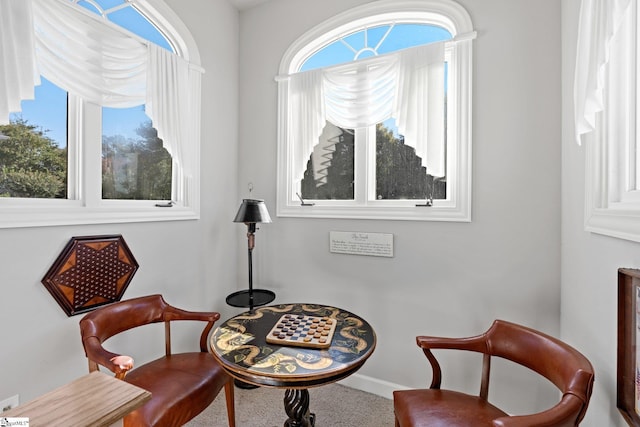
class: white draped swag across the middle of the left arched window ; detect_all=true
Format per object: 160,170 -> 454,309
32,0 -> 147,108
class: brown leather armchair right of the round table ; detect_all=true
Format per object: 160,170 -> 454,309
393,320 -> 594,427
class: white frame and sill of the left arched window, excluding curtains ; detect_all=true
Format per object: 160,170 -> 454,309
0,0 -> 201,229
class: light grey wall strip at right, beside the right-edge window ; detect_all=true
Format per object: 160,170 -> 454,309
561,0 -> 640,427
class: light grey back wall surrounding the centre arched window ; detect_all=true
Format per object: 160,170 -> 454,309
238,0 -> 561,411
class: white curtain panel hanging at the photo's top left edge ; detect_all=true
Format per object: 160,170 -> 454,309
0,0 -> 40,125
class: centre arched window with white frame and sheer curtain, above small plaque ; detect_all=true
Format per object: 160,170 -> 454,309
277,0 -> 475,221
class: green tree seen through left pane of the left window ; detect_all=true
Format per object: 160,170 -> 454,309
0,118 -> 67,198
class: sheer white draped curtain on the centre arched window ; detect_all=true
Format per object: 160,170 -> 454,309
280,42 -> 445,186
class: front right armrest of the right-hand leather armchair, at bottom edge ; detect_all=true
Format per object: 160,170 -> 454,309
493,394 -> 584,427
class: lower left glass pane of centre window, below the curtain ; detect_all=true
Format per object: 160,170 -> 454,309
301,122 -> 354,200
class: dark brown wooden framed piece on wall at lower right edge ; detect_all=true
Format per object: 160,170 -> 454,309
616,268 -> 640,426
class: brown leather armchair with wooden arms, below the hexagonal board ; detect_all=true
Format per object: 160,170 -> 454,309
80,295 -> 235,427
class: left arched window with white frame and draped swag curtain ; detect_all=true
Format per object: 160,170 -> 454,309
0,0 -> 202,227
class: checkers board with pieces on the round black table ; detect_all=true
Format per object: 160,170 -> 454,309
267,314 -> 338,348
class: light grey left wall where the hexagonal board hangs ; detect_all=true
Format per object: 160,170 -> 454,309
0,0 -> 242,408
